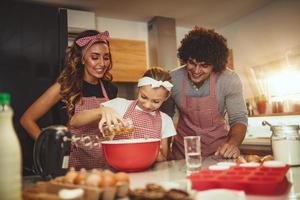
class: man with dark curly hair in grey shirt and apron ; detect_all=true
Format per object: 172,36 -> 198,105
161,27 -> 248,159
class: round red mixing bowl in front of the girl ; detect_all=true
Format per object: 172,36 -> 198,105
102,139 -> 160,172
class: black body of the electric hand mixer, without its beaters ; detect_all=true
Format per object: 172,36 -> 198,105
33,125 -> 71,180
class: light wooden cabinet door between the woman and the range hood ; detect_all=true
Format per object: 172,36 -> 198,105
110,38 -> 147,82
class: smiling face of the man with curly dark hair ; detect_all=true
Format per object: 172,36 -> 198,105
186,59 -> 213,85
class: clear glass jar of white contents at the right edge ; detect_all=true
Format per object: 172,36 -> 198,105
271,125 -> 300,166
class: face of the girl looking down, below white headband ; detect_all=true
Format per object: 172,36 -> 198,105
137,85 -> 170,112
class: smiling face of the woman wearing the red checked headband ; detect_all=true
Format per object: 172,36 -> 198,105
82,43 -> 111,84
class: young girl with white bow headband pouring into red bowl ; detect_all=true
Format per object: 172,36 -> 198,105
99,67 -> 176,161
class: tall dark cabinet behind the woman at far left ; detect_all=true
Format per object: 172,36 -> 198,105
0,1 -> 67,175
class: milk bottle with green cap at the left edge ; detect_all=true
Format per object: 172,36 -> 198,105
0,93 -> 22,200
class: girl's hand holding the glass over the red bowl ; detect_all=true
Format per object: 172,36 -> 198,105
98,106 -> 124,132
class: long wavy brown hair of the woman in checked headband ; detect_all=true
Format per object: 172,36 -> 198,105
57,30 -> 113,119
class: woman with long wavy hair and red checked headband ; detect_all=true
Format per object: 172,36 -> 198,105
20,30 -> 117,168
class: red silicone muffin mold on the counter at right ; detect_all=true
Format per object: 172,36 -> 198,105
188,165 -> 290,195
